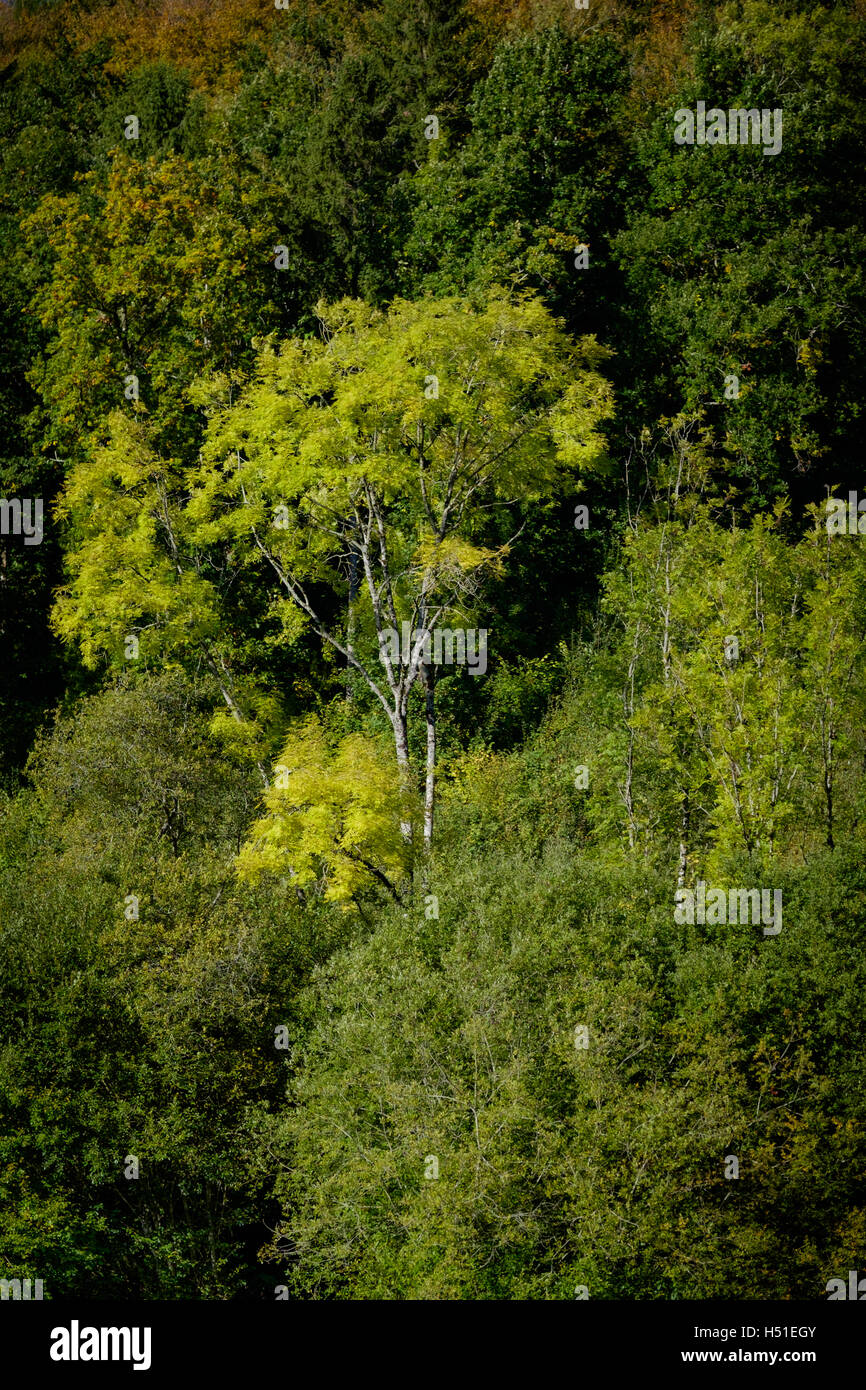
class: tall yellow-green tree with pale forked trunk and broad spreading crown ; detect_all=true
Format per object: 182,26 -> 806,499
57,295 -> 612,872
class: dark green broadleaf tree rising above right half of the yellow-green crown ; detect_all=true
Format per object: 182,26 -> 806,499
403,26 -> 630,335
